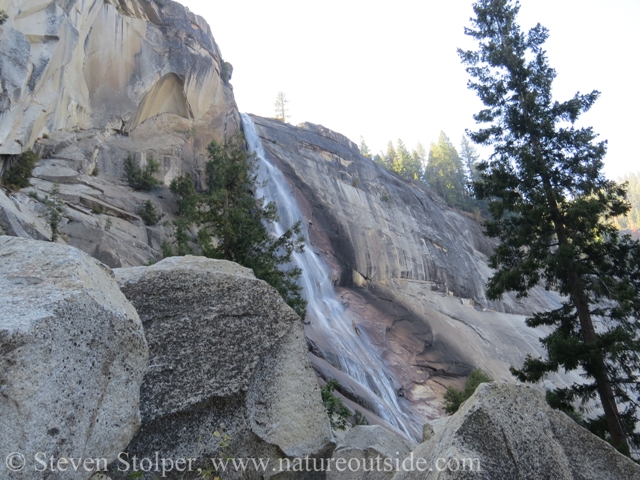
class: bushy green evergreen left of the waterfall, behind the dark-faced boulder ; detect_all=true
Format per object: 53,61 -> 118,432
165,133 -> 306,318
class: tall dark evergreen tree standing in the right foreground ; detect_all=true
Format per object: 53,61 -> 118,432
459,0 -> 640,454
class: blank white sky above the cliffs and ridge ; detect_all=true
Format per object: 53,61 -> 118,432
179,0 -> 640,179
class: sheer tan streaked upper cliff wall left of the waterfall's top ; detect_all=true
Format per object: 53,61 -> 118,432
0,0 -> 238,155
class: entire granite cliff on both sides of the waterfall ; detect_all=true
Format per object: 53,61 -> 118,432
0,0 -> 580,444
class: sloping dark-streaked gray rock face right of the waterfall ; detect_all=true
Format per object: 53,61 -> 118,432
252,116 -> 580,425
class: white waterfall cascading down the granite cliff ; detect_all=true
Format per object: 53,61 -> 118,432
242,114 -> 418,438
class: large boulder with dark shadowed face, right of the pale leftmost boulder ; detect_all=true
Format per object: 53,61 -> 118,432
115,256 -> 331,478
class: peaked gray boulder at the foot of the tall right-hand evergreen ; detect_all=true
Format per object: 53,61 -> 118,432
393,383 -> 640,480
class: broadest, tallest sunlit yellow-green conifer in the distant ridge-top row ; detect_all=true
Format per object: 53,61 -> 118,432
424,132 -> 468,207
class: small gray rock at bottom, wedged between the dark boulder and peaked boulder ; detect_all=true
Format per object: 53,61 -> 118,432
327,425 -> 414,480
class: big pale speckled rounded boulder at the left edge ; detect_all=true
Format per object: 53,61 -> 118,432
0,236 -> 148,479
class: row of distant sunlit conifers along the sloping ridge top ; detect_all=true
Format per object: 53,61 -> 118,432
360,132 -> 486,214
